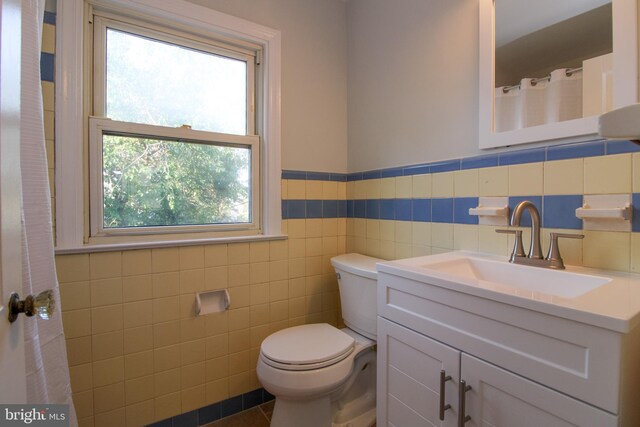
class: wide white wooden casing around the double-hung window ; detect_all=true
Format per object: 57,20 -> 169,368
56,0 -> 282,253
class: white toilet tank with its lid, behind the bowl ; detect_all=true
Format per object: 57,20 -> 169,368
331,254 -> 382,340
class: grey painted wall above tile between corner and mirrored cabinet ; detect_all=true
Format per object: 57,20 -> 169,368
347,0 -> 479,171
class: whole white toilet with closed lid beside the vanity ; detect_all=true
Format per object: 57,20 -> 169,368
257,254 -> 381,427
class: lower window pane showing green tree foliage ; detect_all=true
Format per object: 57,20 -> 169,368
102,134 -> 251,229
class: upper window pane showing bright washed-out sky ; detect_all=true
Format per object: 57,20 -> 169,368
106,28 -> 247,135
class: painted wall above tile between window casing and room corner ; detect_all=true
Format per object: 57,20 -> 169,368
189,0 -> 347,173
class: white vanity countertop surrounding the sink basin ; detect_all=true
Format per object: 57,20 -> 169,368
377,251 -> 640,333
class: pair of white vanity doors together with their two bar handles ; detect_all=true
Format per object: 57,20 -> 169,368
378,317 -> 617,427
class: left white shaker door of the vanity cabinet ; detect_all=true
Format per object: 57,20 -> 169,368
377,317 -> 460,427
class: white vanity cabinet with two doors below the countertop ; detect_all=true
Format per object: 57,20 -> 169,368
377,265 -> 640,427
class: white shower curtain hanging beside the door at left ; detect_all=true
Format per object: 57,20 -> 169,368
20,0 -> 78,426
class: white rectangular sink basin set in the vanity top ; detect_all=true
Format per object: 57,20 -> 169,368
400,252 -> 611,298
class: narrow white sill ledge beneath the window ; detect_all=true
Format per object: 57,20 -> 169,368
55,234 -> 287,255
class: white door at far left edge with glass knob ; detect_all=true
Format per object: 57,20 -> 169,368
0,0 -> 27,403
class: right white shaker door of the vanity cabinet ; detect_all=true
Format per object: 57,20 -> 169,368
460,353 -> 617,427
